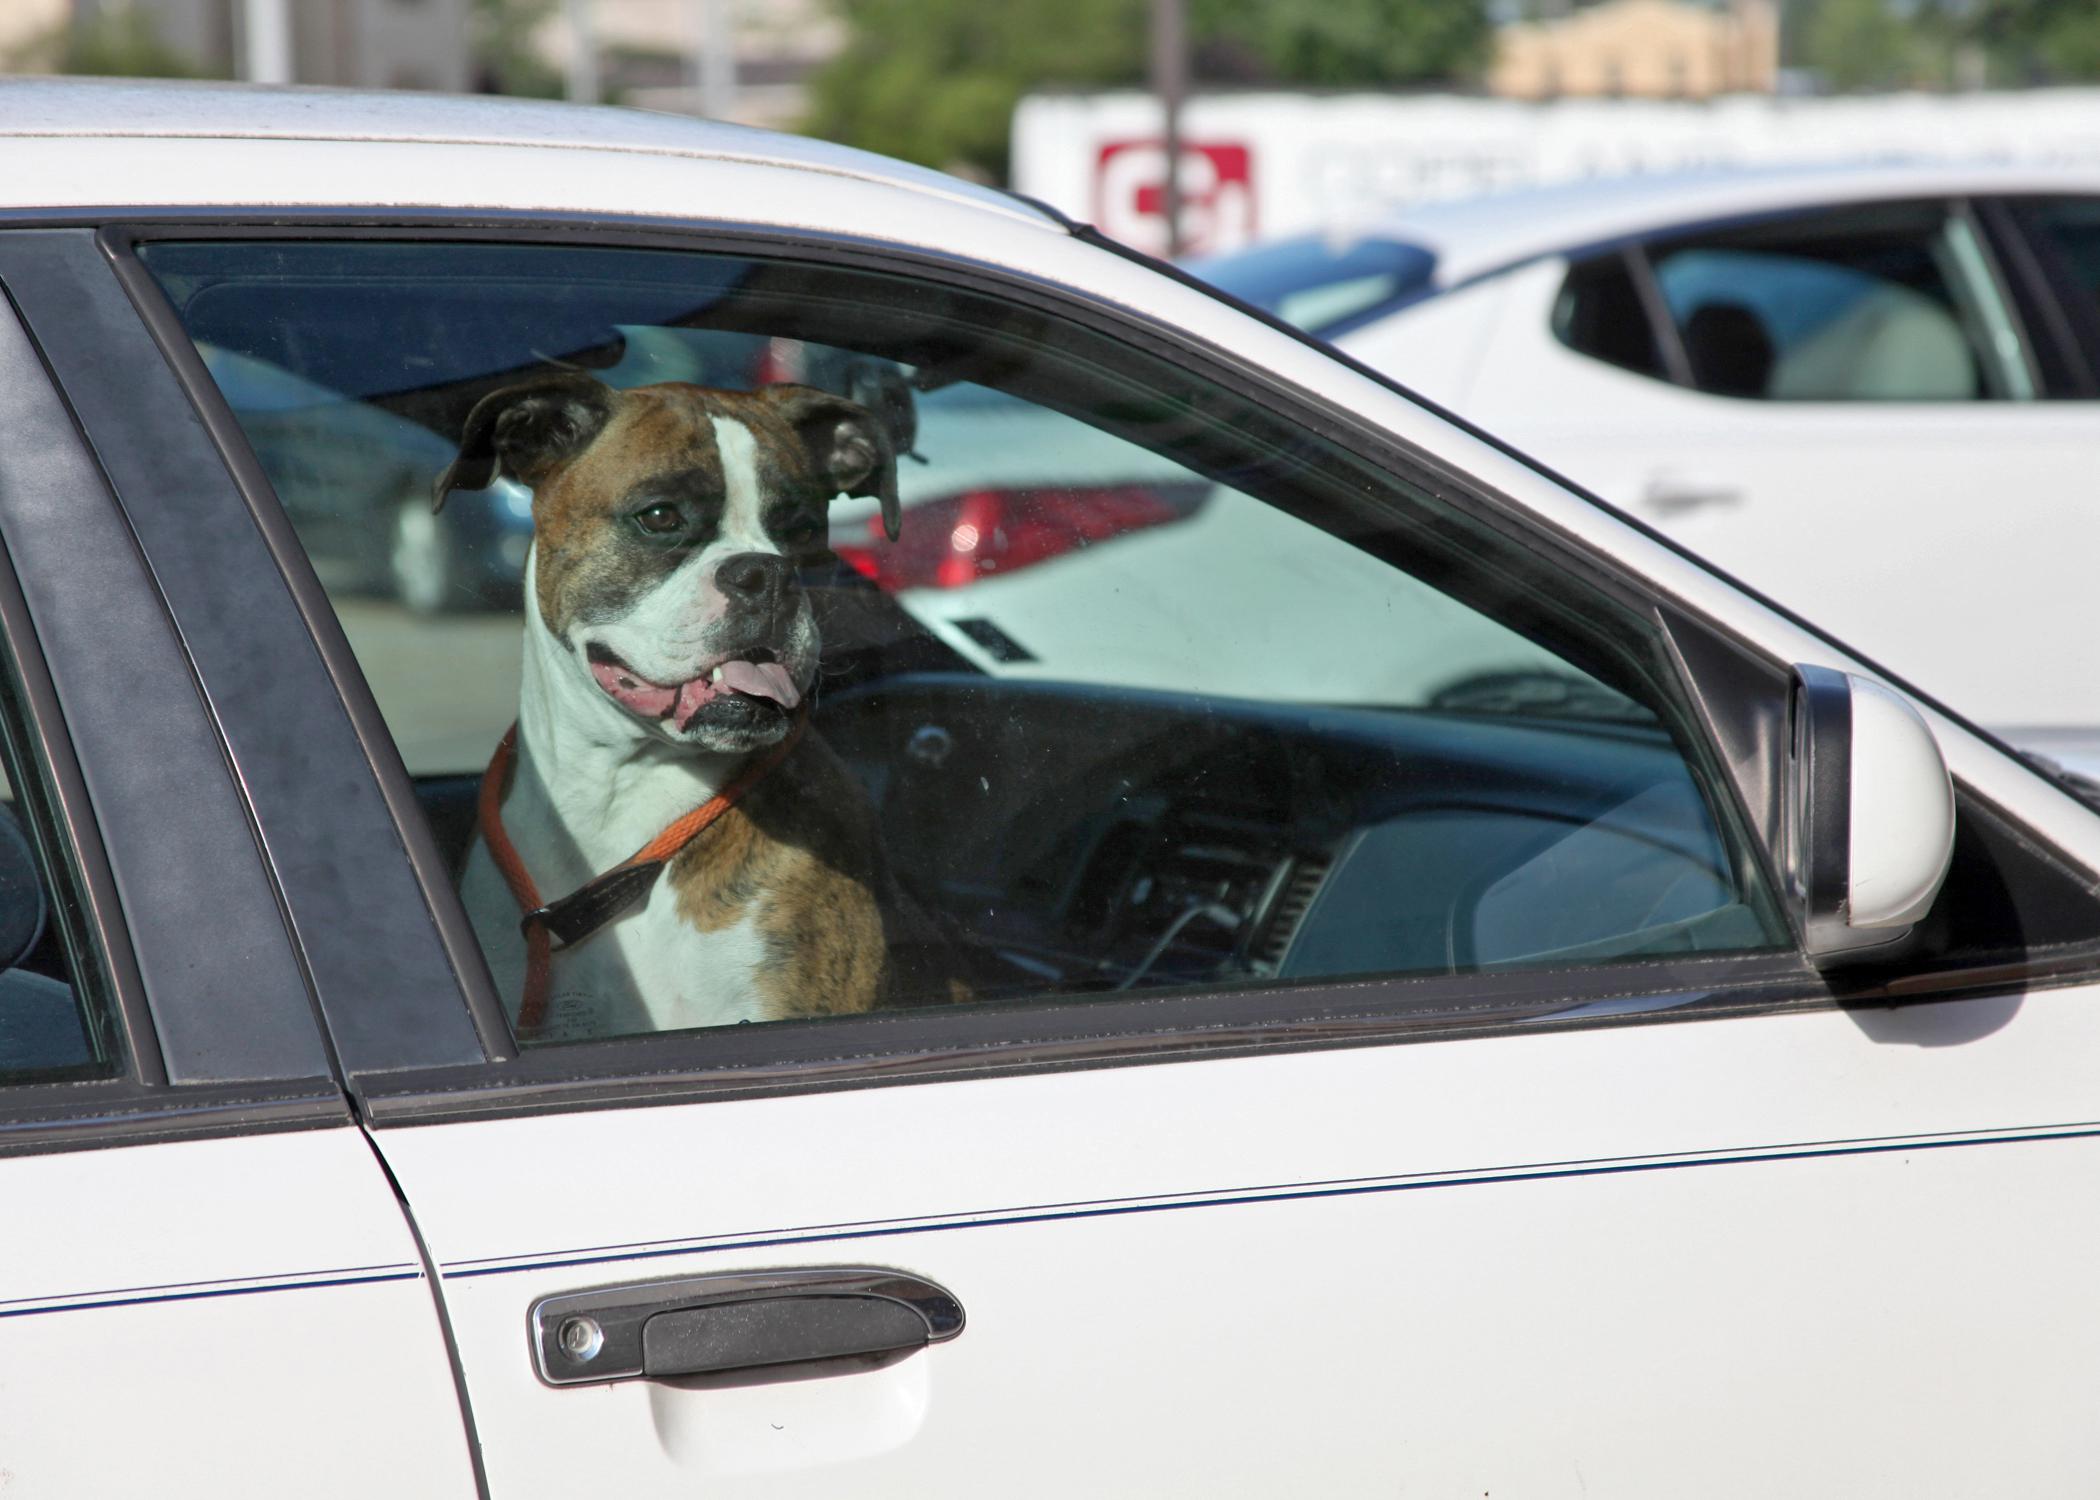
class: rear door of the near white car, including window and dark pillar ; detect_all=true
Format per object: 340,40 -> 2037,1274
0,231 -> 475,1496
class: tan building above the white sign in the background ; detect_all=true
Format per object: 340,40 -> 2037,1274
1487,0 -> 1779,99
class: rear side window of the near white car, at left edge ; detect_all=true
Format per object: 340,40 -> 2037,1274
0,617 -> 120,1086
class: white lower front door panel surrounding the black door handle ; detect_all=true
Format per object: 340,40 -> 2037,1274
382,992 -> 2100,1500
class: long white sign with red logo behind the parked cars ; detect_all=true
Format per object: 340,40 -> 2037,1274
1014,88 -> 2100,254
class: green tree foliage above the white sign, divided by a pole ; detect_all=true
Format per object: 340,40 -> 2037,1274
804,0 -> 1489,179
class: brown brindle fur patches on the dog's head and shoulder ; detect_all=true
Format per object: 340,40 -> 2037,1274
451,376 -> 966,1019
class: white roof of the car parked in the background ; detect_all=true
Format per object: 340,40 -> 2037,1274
1329,162 -> 2100,286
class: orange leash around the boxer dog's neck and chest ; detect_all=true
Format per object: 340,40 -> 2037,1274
479,714 -> 809,1036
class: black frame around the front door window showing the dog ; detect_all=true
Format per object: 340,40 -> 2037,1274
32,210 -> 2100,1126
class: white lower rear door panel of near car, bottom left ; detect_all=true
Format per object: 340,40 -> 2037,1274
0,1128 -> 475,1500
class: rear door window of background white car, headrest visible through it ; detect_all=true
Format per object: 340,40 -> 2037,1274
1649,206 -> 2033,401
